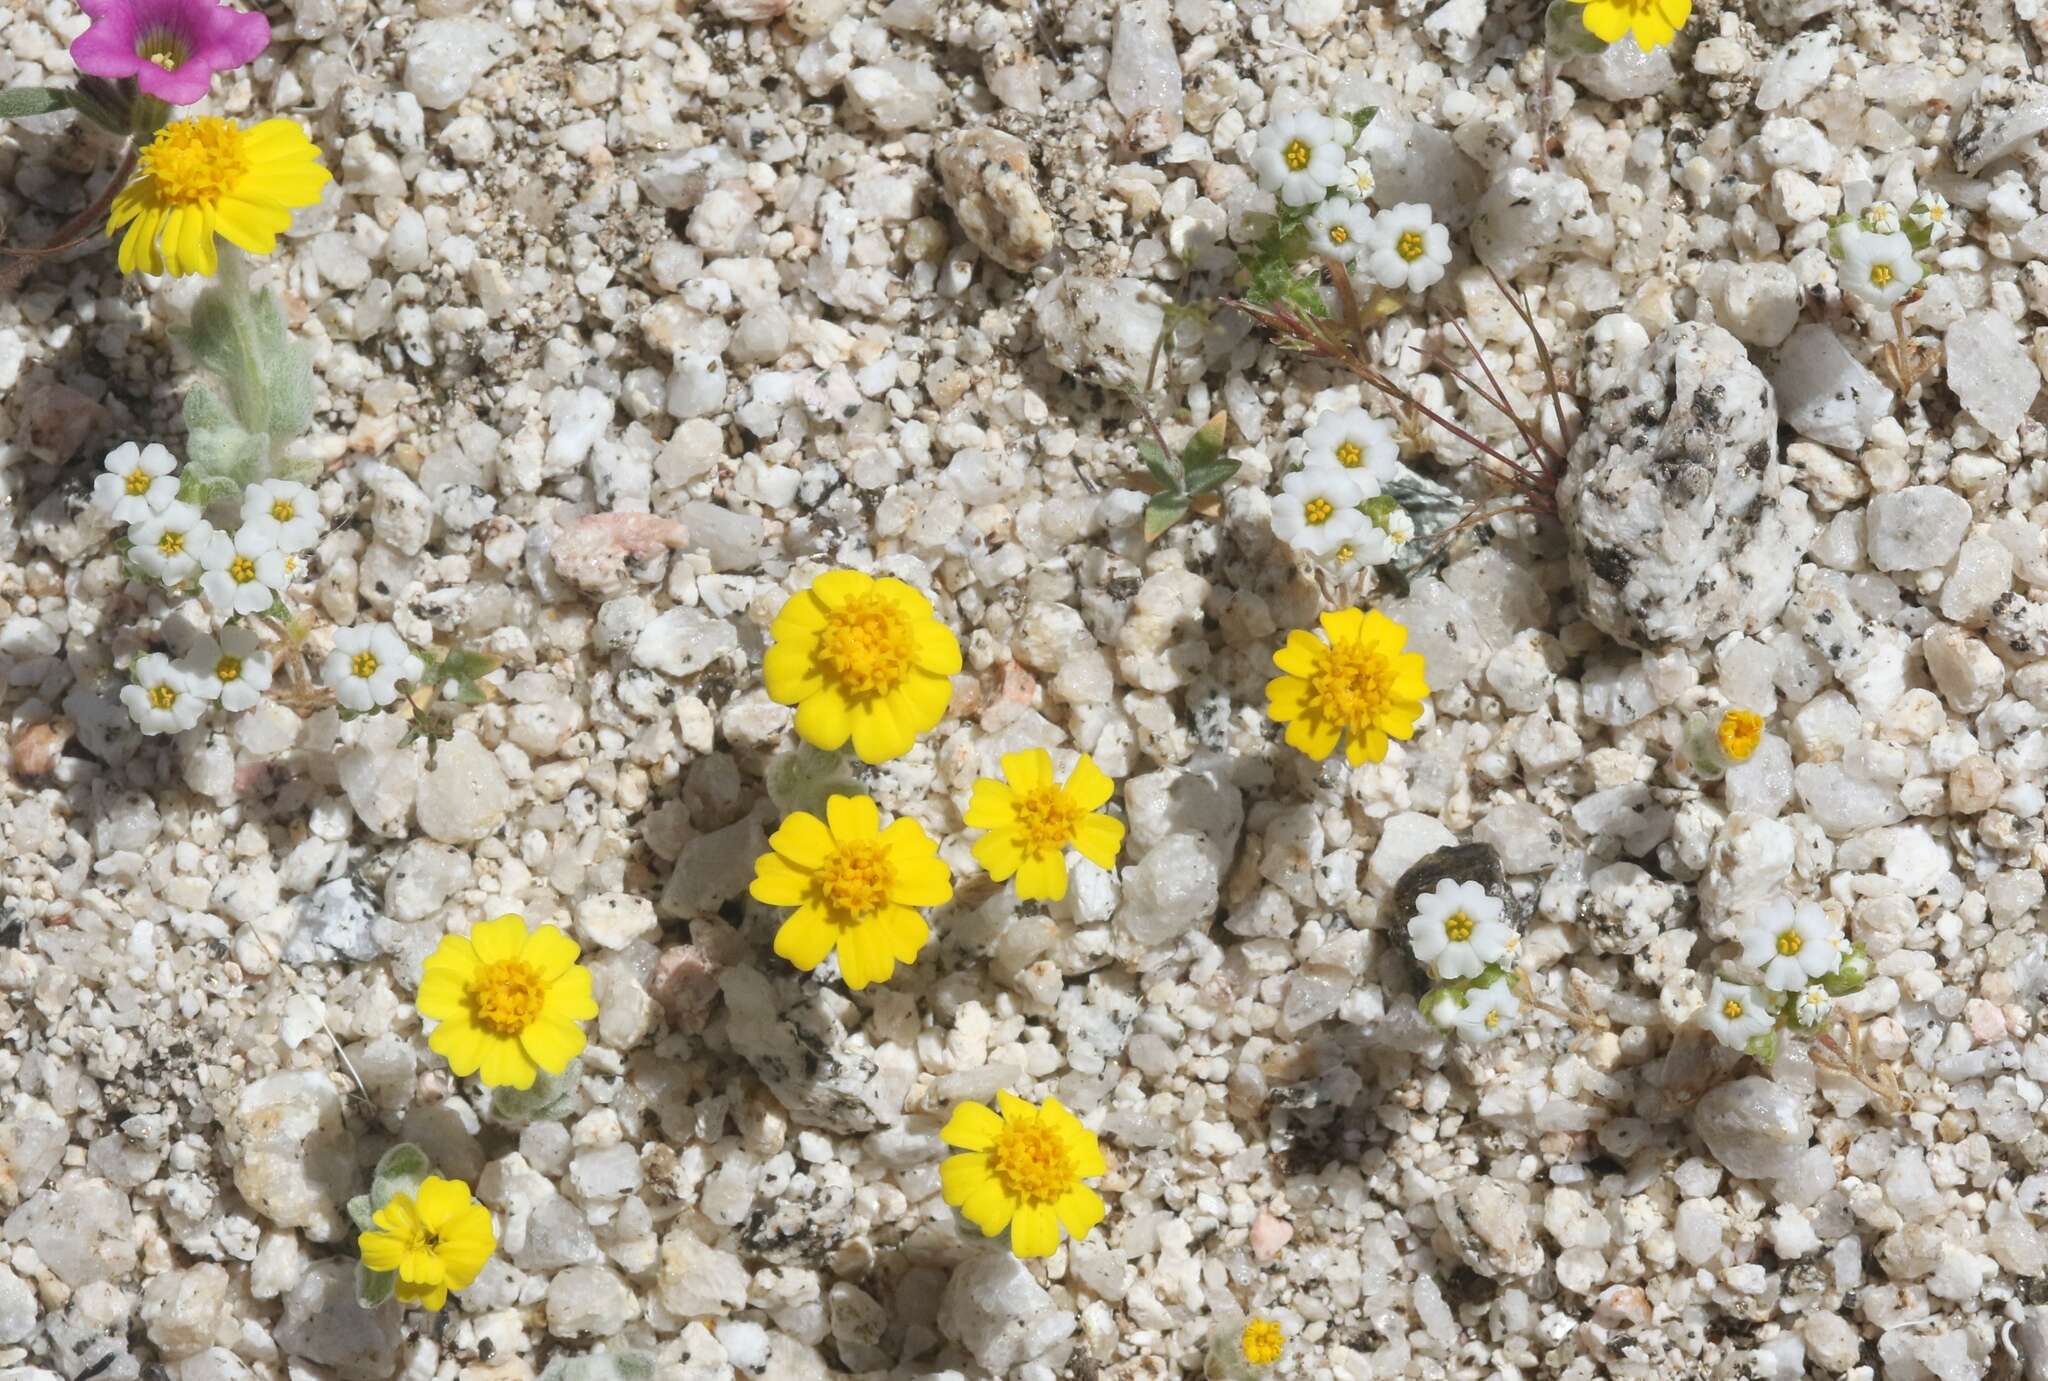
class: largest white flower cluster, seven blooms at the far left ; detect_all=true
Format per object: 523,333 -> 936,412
92,443 -> 426,734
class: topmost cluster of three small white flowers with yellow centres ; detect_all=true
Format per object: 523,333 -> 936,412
1251,111 -> 1450,293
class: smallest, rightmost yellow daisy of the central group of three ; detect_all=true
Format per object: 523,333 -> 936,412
967,748 -> 1124,902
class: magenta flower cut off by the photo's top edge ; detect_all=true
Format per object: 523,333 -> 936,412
72,0 -> 270,104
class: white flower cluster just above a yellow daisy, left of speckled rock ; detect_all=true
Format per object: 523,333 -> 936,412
1272,408 -> 1415,578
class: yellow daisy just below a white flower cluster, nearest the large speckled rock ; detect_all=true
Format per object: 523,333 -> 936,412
1266,609 -> 1430,766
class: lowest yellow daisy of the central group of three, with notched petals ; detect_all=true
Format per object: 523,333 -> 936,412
748,795 -> 952,992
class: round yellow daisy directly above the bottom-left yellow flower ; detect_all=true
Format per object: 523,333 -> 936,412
416,916 -> 598,1088
